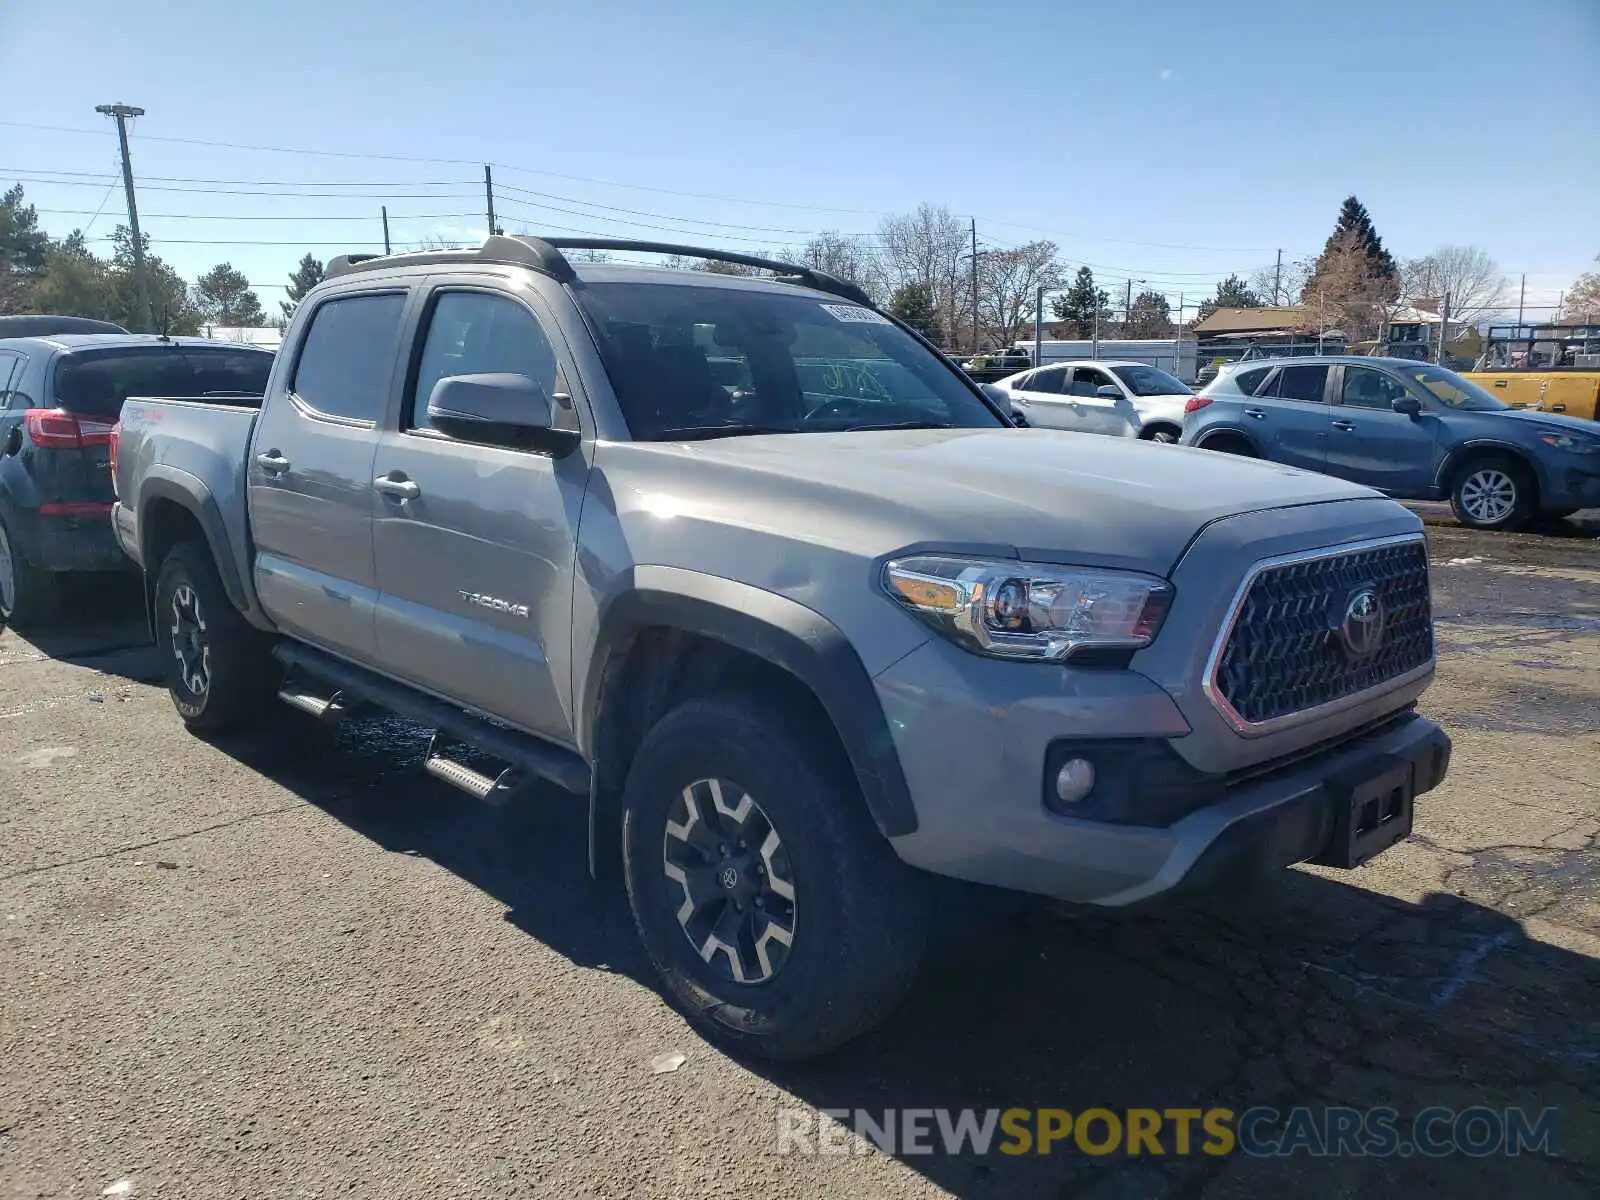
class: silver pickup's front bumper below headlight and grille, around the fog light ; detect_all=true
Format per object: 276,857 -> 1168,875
877,646 -> 1450,906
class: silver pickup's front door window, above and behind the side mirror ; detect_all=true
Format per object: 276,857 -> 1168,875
411,291 -> 578,429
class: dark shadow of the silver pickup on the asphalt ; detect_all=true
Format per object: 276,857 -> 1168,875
206,714 -> 1600,1200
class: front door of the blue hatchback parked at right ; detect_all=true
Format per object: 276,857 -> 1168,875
1328,366 -> 1438,496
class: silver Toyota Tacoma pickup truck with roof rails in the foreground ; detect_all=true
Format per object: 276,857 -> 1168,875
114,237 -> 1450,1058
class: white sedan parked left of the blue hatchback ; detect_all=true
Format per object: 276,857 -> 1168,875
995,358 -> 1194,442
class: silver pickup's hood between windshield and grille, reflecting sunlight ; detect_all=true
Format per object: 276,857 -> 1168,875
619,429 -> 1376,574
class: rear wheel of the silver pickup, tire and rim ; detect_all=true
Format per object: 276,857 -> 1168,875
155,542 -> 274,733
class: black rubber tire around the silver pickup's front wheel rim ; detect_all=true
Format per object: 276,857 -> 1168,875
622,694 -> 928,1059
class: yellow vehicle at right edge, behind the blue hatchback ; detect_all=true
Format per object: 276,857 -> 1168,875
1462,325 -> 1600,421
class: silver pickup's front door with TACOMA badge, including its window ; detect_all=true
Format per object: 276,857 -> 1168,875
373,286 -> 587,741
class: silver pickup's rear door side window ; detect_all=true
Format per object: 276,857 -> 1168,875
290,291 -> 405,421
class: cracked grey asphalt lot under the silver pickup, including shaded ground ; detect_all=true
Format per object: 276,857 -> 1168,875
0,506 -> 1600,1200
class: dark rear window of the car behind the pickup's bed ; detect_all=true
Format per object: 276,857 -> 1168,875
56,346 -> 272,419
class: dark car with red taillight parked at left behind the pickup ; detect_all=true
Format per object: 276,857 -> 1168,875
0,333 -> 272,624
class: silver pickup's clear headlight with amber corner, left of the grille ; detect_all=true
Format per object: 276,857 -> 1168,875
883,555 -> 1173,661
